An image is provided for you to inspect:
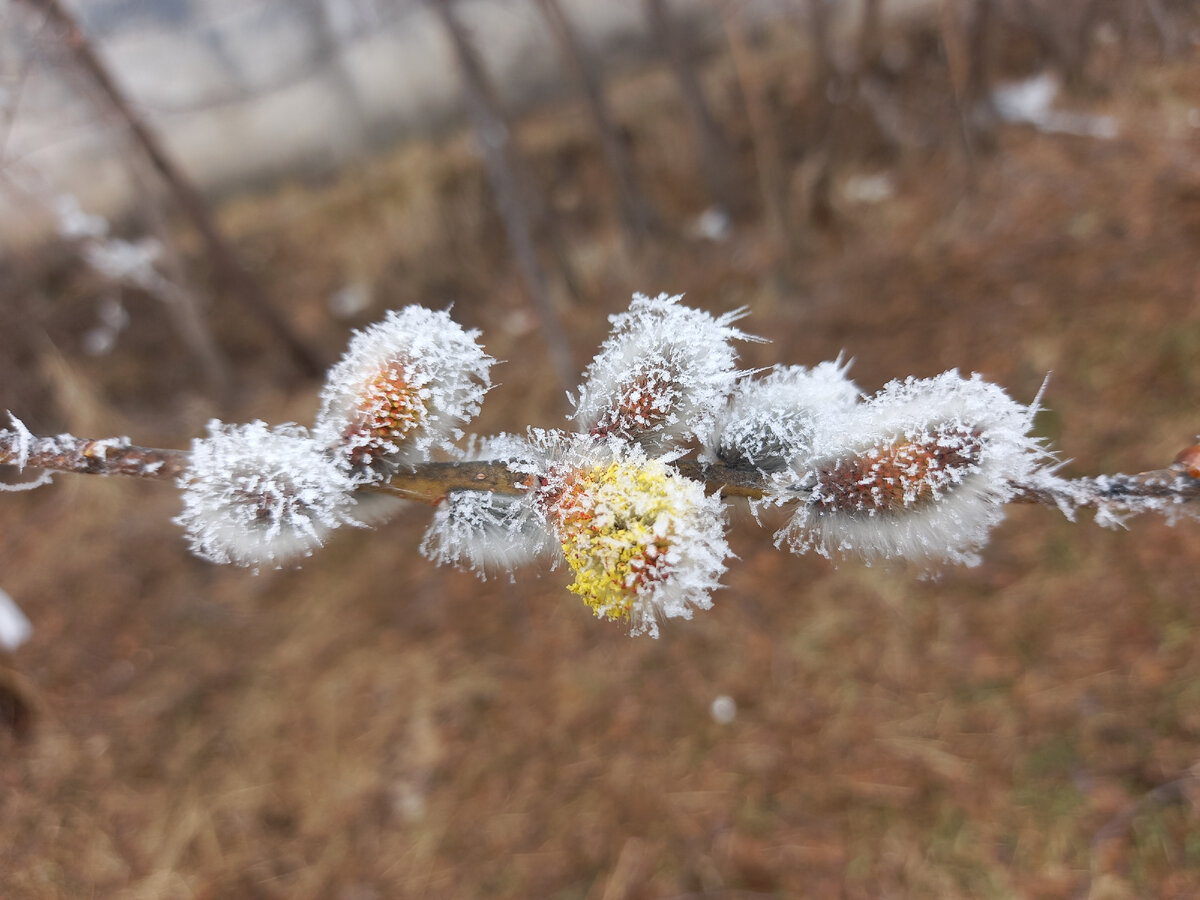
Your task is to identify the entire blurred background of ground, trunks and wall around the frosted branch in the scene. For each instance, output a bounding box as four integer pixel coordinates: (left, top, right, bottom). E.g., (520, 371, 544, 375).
(0, 0, 1200, 900)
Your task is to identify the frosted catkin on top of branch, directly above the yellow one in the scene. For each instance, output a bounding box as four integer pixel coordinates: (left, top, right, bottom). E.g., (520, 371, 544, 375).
(572, 294, 755, 451)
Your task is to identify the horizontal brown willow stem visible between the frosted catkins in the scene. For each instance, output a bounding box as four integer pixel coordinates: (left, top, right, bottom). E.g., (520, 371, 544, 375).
(0, 421, 1200, 509)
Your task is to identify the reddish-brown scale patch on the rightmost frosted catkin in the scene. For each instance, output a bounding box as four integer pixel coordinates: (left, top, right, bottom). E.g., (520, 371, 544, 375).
(818, 427, 983, 512)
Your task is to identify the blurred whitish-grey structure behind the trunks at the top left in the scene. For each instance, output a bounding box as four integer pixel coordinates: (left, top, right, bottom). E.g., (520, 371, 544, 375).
(0, 0, 931, 240)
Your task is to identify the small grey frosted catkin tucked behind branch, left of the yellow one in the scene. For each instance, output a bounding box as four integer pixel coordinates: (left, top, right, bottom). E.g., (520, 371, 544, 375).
(421, 434, 556, 578)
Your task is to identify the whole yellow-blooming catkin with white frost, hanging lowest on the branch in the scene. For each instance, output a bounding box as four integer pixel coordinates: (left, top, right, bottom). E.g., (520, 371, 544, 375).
(540, 440, 730, 637)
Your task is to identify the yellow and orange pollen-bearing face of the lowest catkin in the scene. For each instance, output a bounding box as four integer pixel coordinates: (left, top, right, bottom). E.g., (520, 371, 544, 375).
(553, 461, 686, 620)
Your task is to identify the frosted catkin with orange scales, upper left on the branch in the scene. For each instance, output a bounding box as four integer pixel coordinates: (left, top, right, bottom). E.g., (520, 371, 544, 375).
(314, 306, 496, 481)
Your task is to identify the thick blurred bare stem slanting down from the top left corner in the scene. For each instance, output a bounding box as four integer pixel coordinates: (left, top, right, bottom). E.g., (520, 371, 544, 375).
(24, 0, 325, 377)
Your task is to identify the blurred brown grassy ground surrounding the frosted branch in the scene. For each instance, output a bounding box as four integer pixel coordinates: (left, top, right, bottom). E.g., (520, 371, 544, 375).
(0, 12, 1200, 900)
